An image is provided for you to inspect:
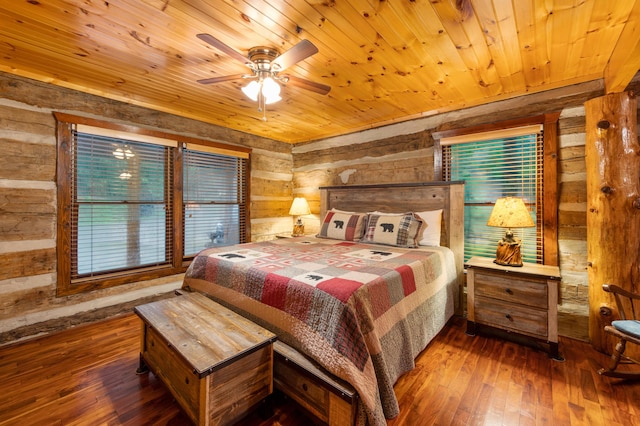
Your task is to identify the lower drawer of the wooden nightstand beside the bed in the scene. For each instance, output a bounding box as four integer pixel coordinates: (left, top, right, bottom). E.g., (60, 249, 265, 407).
(475, 296, 548, 338)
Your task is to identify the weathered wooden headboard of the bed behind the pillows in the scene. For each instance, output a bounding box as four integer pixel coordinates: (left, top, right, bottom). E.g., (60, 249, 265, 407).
(320, 182, 464, 314)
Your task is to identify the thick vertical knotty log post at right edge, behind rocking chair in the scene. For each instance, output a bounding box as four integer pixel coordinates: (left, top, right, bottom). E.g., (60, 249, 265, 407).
(585, 92, 640, 353)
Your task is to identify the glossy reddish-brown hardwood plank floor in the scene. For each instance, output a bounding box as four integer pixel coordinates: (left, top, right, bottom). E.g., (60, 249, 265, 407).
(0, 314, 640, 426)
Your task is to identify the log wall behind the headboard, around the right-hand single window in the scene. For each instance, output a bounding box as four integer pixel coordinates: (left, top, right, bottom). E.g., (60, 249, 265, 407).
(293, 78, 640, 340)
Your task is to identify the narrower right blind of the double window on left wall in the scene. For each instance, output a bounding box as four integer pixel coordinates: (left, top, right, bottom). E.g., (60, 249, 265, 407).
(183, 144, 247, 257)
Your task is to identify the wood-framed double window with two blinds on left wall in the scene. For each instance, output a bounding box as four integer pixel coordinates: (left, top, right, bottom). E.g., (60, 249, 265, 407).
(56, 114, 249, 295)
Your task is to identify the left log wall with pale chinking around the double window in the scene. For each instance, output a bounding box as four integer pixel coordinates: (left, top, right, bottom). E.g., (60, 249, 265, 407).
(0, 73, 293, 345)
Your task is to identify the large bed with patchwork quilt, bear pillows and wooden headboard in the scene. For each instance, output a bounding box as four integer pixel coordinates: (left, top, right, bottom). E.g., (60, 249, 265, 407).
(183, 182, 464, 425)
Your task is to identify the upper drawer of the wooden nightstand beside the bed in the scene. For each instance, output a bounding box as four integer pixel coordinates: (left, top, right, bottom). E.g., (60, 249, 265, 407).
(475, 270, 548, 309)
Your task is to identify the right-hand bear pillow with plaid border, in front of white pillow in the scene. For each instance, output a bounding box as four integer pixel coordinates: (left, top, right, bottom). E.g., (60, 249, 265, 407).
(360, 212, 424, 248)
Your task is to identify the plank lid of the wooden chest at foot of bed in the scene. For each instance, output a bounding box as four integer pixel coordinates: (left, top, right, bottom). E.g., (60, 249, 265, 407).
(134, 293, 276, 378)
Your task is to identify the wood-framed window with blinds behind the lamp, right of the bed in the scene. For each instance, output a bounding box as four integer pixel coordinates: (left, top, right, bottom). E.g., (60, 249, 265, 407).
(433, 114, 558, 265)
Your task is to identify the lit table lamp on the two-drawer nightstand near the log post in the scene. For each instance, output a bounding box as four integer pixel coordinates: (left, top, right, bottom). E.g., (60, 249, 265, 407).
(487, 197, 536, 266)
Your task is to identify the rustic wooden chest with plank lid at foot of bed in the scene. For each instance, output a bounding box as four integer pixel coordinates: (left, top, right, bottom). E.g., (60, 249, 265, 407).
(135, 293, 276, 425)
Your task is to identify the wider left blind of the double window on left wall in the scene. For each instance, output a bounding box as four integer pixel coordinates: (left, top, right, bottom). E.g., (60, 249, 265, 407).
(71, 131, 173, 279)
